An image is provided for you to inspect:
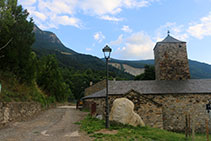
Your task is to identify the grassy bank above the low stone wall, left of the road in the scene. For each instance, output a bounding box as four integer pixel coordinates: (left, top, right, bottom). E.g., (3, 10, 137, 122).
(0, 72, 55, 107)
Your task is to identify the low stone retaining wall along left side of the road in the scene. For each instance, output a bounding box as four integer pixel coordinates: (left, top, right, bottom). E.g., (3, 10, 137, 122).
(0, 102, 42, 127)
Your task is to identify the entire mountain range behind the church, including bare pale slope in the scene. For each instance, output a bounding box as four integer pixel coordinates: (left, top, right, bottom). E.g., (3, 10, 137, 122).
(32, 25, 211, 79)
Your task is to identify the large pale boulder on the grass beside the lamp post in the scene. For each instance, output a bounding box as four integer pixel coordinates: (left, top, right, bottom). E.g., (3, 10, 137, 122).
(109, 98, 145, 126)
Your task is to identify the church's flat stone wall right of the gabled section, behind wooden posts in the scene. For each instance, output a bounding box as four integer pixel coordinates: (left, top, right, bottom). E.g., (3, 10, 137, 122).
(159, 94, 211, 132)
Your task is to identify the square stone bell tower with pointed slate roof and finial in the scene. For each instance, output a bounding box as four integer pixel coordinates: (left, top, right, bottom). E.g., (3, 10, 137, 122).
(154, 31, 190, 80)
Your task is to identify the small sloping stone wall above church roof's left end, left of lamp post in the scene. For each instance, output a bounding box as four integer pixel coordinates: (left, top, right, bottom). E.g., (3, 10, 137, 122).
(84, 80, 106, 96)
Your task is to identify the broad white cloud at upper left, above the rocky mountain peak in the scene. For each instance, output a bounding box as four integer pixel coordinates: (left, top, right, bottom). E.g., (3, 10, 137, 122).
(20, 0, 79, 29)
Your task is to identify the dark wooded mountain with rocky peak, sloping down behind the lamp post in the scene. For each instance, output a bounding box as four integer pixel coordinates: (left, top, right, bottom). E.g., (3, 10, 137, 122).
(32, 25, 133, 79)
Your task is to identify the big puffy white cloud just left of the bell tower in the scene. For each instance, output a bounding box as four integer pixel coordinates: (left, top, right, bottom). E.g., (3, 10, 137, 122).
(116, 32, 155, 59)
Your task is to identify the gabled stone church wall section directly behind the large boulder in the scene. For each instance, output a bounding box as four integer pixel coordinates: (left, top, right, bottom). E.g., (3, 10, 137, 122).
(84, 91, 163, 128)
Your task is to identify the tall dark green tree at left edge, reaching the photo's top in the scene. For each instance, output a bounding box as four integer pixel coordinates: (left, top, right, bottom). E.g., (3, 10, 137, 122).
(0, 0, 35, 82)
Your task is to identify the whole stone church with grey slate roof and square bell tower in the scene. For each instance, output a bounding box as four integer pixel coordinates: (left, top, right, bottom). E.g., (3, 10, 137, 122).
(83, 34, 211, 132)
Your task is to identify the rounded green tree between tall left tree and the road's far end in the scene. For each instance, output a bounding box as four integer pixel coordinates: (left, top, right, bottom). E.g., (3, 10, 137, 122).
(37, 55, 72, 102)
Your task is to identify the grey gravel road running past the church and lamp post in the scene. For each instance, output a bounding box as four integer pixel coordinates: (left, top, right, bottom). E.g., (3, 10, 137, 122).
(0, 106, 91, 141)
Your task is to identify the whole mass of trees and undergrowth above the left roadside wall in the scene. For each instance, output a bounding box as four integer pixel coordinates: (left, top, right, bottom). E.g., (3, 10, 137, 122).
(0, 0, 72, 104)
